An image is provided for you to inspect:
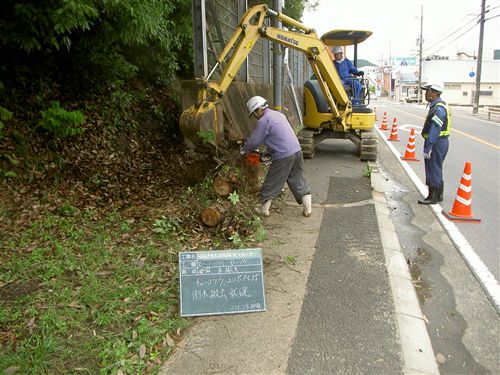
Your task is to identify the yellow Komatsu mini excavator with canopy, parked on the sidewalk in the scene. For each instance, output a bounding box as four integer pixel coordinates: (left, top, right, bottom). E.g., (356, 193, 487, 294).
(180, 4, 377, 160)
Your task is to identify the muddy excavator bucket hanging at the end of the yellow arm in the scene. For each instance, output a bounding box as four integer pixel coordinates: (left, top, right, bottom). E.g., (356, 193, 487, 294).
(179, 101, 224, 151)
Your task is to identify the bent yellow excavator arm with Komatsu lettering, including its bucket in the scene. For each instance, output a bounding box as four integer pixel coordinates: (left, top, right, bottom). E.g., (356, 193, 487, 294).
(180, 4, 352, 147)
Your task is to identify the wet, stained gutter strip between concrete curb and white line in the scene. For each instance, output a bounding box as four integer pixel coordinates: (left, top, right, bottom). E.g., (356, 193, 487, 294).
(377, 119, 500, 375)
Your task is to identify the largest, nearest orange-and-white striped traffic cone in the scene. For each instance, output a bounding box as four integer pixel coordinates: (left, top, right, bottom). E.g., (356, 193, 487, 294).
(443, 161, 481, 224)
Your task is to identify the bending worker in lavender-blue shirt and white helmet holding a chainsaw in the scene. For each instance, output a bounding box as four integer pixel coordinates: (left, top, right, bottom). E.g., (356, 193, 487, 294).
(240, 96, 312, 217)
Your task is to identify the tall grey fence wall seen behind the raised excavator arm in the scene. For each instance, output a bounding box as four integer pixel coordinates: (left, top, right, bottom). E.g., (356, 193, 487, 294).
(192, 0, 311, 85)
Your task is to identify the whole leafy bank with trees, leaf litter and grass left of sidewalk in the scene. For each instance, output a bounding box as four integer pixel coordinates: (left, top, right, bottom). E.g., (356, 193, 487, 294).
(0, 0, 314, 374)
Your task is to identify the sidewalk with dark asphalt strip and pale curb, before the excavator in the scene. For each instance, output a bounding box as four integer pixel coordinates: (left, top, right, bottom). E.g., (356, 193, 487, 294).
(160, 141, 438, 375)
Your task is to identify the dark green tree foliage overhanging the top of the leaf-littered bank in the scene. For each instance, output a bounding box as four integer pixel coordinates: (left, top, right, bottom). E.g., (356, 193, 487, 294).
(0, 0, 192, 93)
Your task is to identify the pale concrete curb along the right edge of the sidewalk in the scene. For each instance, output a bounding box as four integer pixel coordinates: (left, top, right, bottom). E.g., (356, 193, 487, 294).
(368, 162, 439, 375)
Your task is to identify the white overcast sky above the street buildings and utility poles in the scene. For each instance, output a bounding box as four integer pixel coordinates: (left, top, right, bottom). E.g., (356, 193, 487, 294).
(302, 0, 500, 65)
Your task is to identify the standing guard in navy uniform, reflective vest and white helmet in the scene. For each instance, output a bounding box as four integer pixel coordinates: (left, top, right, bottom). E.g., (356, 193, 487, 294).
(418, 83, 451, 204)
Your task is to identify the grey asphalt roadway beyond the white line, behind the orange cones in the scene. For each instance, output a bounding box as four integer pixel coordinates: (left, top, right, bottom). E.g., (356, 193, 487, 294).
(372, 98, 500, 280)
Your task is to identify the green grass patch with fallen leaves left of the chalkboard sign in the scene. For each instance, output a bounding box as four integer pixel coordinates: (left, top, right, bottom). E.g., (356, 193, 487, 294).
(0, 185, 267, 374)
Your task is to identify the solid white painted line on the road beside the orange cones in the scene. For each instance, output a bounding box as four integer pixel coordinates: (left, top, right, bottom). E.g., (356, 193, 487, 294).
(375, 127, 500, 314)
